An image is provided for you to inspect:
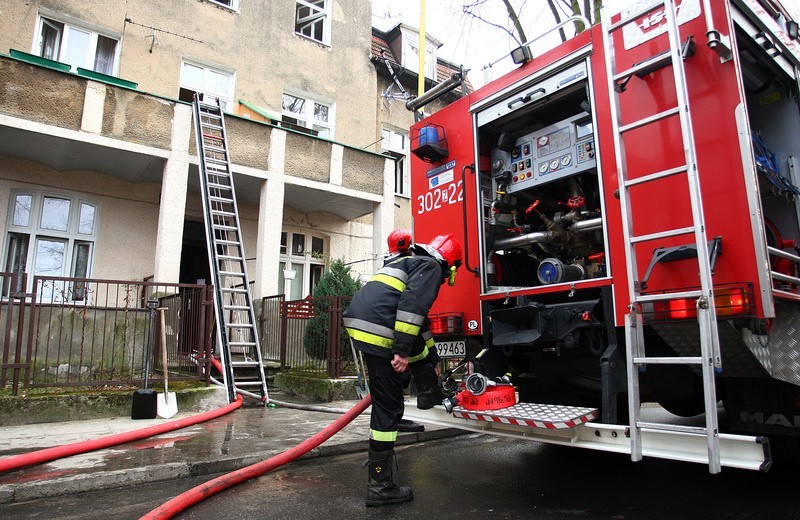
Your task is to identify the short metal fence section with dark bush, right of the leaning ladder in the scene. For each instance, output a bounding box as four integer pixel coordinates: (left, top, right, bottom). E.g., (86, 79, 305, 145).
(261, 295, 356, 379)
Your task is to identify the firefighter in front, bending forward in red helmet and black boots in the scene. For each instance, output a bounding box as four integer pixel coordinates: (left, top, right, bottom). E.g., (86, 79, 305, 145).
(344, 234, 462, 506)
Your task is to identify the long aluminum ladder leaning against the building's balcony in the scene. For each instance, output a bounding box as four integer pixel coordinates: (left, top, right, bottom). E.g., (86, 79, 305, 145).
(193, 96, 269, 404)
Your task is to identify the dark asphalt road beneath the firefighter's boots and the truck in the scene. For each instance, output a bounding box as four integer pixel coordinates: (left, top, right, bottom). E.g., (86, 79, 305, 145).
(0, 435, 800, 520)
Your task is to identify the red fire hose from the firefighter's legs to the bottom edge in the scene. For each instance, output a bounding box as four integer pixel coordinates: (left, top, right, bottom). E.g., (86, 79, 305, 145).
(140, 395, 372, 520)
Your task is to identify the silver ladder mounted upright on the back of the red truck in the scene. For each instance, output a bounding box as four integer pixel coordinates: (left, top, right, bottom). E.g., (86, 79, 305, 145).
(602, 0, 721, 473)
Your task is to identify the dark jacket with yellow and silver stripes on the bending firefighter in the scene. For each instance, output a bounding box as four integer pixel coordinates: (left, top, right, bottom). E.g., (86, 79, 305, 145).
(343, 255, 443, 357)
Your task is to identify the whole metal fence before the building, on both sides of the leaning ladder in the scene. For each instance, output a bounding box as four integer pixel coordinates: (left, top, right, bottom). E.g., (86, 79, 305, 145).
(0, 273, 356, 395)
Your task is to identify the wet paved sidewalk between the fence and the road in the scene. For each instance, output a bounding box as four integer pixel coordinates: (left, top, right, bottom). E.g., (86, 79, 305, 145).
(0, 392, 461, 503)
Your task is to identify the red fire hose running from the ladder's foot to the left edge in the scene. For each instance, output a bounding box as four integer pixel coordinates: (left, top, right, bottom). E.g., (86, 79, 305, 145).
(0, 395, 242, 472)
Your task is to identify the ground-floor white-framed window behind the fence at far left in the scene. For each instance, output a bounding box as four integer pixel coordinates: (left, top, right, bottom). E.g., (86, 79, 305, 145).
(3, 190, 98, 302)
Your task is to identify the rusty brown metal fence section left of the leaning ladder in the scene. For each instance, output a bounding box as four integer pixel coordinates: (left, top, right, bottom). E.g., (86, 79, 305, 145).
(0, 273, 213, 394)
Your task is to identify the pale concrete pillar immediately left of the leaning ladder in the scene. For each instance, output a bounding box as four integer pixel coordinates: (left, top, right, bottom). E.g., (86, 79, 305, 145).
(153, 104, 192, 283)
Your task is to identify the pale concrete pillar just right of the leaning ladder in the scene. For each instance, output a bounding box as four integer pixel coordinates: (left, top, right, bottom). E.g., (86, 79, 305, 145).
(252, 128, 286, 300)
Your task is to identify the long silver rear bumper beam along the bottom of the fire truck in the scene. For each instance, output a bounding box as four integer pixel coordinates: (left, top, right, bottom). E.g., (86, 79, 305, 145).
(403, 401, 772, 472)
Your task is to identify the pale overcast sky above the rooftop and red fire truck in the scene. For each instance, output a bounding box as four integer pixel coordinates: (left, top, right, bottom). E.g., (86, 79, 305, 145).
(372, 0, 800, 88)
